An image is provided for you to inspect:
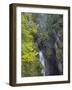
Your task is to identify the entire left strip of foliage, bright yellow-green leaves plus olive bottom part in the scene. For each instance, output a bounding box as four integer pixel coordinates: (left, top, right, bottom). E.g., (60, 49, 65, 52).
(21, 13, 41, 76)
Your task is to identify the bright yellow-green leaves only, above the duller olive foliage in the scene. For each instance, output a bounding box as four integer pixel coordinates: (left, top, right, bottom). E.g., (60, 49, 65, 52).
(22, 14, 37, 61)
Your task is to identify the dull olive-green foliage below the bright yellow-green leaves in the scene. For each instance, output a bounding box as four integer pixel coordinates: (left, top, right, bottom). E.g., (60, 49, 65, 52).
(22, 60, 42, 77)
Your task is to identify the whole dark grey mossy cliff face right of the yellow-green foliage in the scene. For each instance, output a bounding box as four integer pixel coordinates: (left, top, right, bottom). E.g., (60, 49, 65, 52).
(32, 14, 63, 75)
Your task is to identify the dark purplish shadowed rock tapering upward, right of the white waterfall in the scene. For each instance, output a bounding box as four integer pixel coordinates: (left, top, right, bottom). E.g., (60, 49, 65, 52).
(46, 49, 60, 75)
